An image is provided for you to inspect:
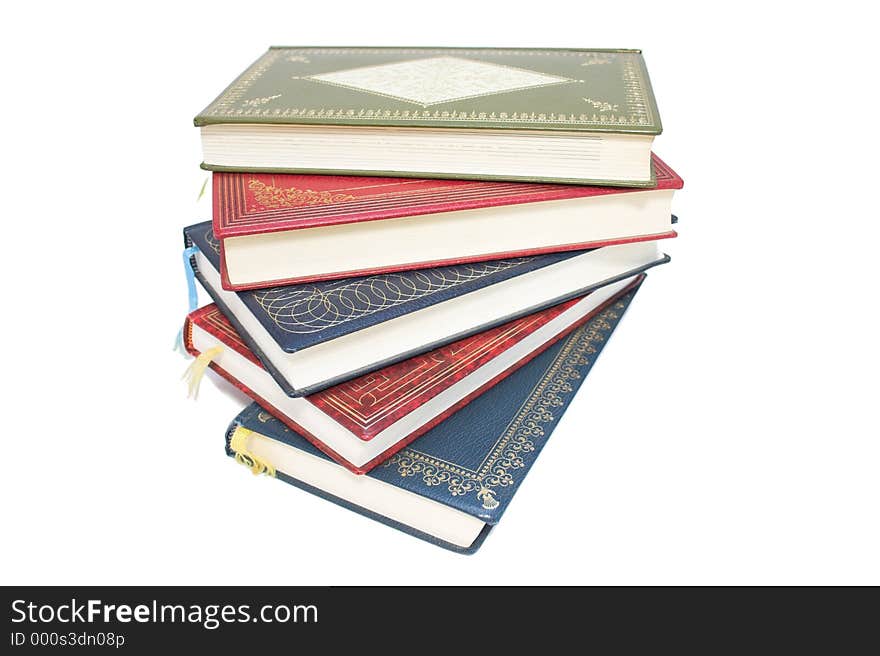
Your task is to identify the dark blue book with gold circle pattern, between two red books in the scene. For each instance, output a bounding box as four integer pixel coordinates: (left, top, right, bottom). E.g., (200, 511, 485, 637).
(184, 222, 669, 396)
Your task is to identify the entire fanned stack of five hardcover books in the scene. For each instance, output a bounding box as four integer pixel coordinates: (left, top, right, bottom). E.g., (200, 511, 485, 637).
(182, 47, 682, 553)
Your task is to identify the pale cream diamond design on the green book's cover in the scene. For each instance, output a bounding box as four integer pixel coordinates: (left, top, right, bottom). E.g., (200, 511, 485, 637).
(306, 57, 575, 107)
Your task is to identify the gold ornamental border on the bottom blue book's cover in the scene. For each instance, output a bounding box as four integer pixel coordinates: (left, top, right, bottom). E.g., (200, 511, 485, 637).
(383, 300, 626, 510)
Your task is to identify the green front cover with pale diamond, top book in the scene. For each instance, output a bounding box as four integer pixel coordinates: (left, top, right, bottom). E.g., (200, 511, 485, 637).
(194, 47, 662, 135)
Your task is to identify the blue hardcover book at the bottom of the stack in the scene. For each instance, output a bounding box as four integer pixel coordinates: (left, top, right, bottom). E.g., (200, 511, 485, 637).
(226, 287, 638, 553)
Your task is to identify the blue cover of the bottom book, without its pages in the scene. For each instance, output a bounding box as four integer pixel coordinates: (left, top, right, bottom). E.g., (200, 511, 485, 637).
(226, 280, 637, 553)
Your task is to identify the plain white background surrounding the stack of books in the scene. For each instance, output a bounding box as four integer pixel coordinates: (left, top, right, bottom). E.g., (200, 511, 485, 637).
(0, 0, 880, 584)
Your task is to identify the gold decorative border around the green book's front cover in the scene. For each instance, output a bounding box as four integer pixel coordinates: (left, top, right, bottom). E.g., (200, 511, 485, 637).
(198, 48, 657, 127)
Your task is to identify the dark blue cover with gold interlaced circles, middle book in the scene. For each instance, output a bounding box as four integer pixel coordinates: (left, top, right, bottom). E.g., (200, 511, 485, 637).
(184, 221, 584, 353)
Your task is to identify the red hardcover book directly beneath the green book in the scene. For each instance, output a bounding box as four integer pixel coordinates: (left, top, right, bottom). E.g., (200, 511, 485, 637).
(213, 156, 682, 290)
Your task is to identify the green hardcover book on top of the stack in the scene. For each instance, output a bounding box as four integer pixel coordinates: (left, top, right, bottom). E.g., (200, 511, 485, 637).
(195, 47, 661, 187)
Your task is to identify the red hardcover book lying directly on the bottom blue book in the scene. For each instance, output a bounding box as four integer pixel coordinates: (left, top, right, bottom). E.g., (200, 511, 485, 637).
(184, 275, 644, 474)
